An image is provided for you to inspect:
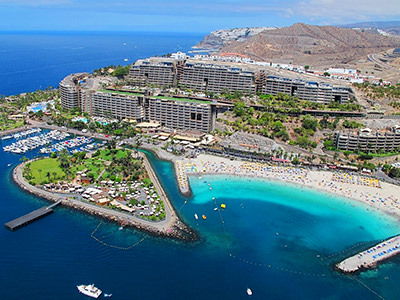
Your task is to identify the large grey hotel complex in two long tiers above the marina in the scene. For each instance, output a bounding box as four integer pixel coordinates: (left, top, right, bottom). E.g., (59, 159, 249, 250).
(60, 57, 352, 132)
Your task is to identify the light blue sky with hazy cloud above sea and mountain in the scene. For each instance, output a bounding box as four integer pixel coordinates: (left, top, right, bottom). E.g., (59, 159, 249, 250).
(0, 0, 400, 32)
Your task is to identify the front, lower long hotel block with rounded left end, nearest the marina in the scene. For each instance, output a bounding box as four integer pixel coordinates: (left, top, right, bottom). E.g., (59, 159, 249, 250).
(60, 75, 216, 132)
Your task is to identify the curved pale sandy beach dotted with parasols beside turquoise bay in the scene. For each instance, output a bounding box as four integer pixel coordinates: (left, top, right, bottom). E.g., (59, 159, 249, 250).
(175, 154, 400, 219)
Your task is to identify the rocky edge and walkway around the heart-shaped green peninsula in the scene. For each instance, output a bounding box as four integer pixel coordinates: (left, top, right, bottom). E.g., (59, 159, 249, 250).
(12, 161, 199, 242)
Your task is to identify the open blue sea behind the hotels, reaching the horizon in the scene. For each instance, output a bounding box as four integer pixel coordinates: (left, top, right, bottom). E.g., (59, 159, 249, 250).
(0, 32, 203, 96)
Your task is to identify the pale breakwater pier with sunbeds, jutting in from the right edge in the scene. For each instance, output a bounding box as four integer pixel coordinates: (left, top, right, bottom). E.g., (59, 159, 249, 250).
(336, 235, 400, 273)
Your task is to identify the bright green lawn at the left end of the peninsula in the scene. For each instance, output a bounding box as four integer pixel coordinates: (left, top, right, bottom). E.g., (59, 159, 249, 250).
(31, 158, 65, 184)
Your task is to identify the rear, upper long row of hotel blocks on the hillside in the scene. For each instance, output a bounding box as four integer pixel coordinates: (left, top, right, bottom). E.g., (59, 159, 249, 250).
(129, 58, 352, 104)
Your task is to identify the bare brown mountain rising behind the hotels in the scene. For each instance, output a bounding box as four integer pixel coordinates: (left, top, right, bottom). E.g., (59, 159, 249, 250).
(220, 23, 400, 67)
